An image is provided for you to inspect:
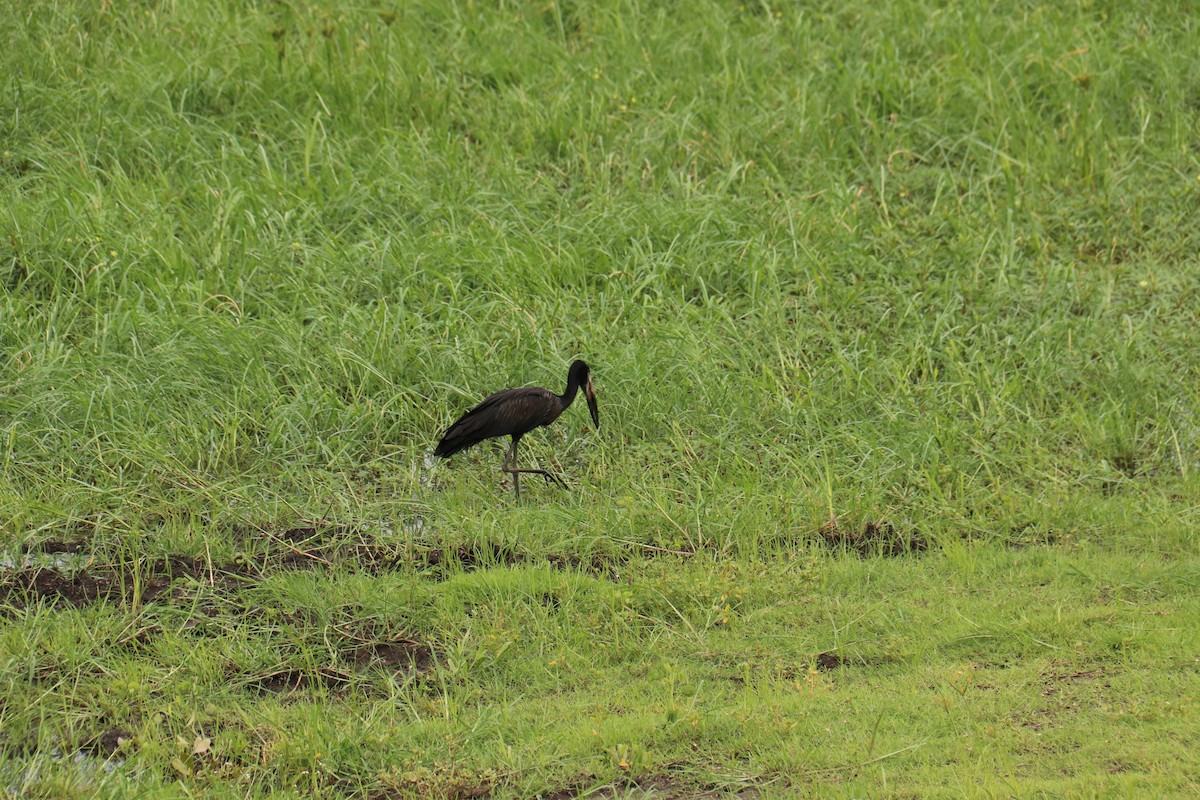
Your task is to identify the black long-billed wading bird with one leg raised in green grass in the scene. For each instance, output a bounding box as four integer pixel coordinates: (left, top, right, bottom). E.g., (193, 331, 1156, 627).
(433, 361, 600, 500)
